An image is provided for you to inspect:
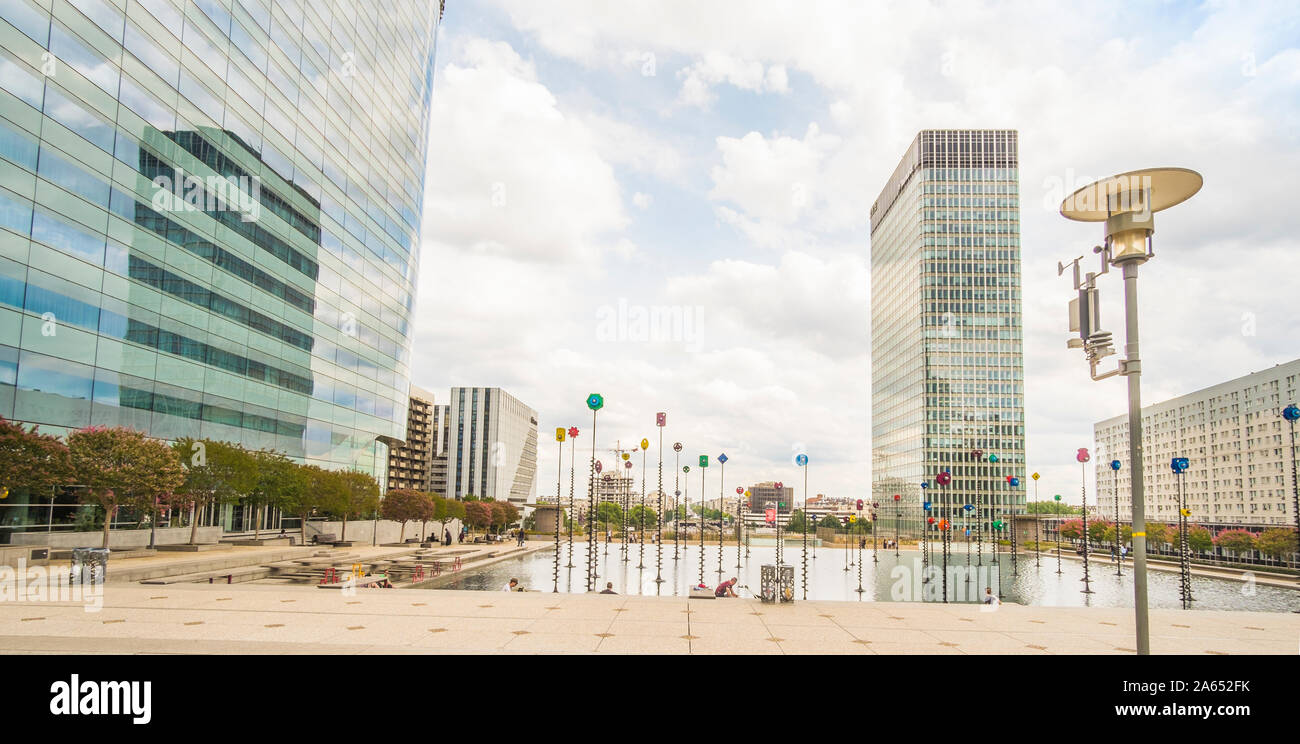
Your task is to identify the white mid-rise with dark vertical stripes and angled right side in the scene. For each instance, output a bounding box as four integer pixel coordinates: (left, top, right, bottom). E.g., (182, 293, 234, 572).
(445, 388, 537, 506)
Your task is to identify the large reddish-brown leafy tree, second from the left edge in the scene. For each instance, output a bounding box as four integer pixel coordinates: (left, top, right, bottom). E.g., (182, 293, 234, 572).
(68, 427, 185, 548)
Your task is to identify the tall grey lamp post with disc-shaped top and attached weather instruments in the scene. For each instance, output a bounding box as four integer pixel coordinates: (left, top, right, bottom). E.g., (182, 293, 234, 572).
(1057, 168, 1203, 654)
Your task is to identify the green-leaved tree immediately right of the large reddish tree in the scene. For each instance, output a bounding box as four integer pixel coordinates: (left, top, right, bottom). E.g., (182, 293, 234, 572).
(172, 437, 257, 545)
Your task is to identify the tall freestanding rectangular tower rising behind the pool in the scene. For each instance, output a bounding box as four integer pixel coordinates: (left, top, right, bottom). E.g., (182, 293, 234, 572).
(871, 130, 1027, 536)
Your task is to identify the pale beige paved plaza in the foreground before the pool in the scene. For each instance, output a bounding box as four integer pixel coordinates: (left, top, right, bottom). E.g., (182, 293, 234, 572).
(0, 584, 1300, 654)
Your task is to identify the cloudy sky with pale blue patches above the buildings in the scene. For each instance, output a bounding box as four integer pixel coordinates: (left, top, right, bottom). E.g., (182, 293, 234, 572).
(412, 0, 1300, 503)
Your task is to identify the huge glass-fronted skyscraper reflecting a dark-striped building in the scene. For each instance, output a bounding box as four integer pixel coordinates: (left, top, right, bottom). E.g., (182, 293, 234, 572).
(0, 0, 441, 496)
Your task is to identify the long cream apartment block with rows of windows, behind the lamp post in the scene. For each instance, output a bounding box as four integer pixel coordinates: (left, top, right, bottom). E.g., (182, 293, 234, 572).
(1095, 359, 1300, 528)
